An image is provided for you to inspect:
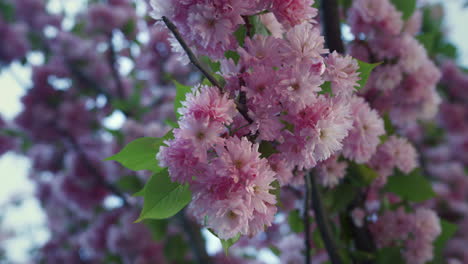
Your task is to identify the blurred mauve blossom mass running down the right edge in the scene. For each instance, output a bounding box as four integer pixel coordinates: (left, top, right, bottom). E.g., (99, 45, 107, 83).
(417, 61, 468, 263)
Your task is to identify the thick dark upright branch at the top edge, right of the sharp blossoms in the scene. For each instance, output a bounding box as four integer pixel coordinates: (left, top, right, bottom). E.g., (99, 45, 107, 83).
(320, 0, 345, 53)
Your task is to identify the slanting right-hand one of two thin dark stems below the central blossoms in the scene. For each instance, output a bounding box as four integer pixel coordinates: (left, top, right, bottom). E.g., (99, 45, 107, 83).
(306, 171, 343, 264)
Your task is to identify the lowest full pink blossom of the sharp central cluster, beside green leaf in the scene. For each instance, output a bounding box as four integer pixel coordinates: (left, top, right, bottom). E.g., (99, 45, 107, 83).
(186, 137, 276, 239)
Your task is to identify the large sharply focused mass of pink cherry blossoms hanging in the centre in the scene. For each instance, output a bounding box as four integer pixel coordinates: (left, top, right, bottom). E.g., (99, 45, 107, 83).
(153, 1, 392, 238)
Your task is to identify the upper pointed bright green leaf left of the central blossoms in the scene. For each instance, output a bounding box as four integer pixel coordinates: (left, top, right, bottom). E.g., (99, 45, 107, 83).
(105, 131, 173, 172)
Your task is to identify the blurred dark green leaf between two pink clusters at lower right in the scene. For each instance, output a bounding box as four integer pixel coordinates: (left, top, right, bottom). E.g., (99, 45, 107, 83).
(384, 169, 436, 202)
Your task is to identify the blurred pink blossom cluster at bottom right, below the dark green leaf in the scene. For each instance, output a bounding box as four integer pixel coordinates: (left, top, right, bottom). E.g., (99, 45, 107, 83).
(370, 208, 441, 264)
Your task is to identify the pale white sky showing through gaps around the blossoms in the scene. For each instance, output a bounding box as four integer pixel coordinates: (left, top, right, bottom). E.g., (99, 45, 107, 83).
(0, 0, 468, 263)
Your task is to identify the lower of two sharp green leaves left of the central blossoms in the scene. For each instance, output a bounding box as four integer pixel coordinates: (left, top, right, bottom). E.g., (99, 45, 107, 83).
(136, 169, 192, 222)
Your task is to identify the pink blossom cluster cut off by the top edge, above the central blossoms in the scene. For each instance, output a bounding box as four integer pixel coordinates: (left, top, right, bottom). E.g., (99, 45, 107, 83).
(151, 0, 317, 59)
